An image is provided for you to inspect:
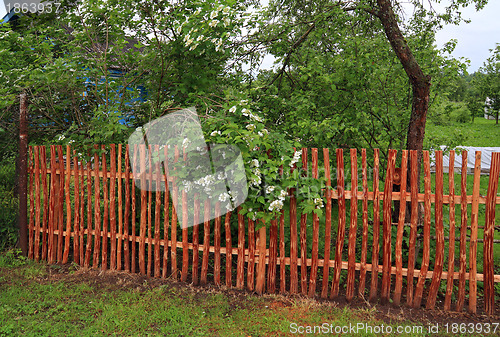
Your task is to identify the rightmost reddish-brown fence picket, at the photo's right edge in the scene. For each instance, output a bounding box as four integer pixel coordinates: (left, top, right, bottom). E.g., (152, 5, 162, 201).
(483, 152, 500, 315)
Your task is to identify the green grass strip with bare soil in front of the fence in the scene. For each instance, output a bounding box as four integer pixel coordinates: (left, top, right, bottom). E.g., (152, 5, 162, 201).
(0, 253, 498, 336)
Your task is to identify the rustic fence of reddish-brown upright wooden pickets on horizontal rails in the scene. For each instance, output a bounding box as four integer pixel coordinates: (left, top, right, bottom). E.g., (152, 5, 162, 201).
(29, 145, 500, 314)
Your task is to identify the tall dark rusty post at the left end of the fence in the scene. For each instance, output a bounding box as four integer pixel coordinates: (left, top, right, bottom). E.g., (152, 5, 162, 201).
(19, 92, 28, 256)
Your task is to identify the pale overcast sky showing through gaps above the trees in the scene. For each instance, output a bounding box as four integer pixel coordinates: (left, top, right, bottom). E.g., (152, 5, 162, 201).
(0, 0, 500, 73)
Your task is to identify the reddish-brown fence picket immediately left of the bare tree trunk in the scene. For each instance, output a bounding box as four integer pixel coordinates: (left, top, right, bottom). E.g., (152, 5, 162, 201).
(393, 150, 408, 305)
